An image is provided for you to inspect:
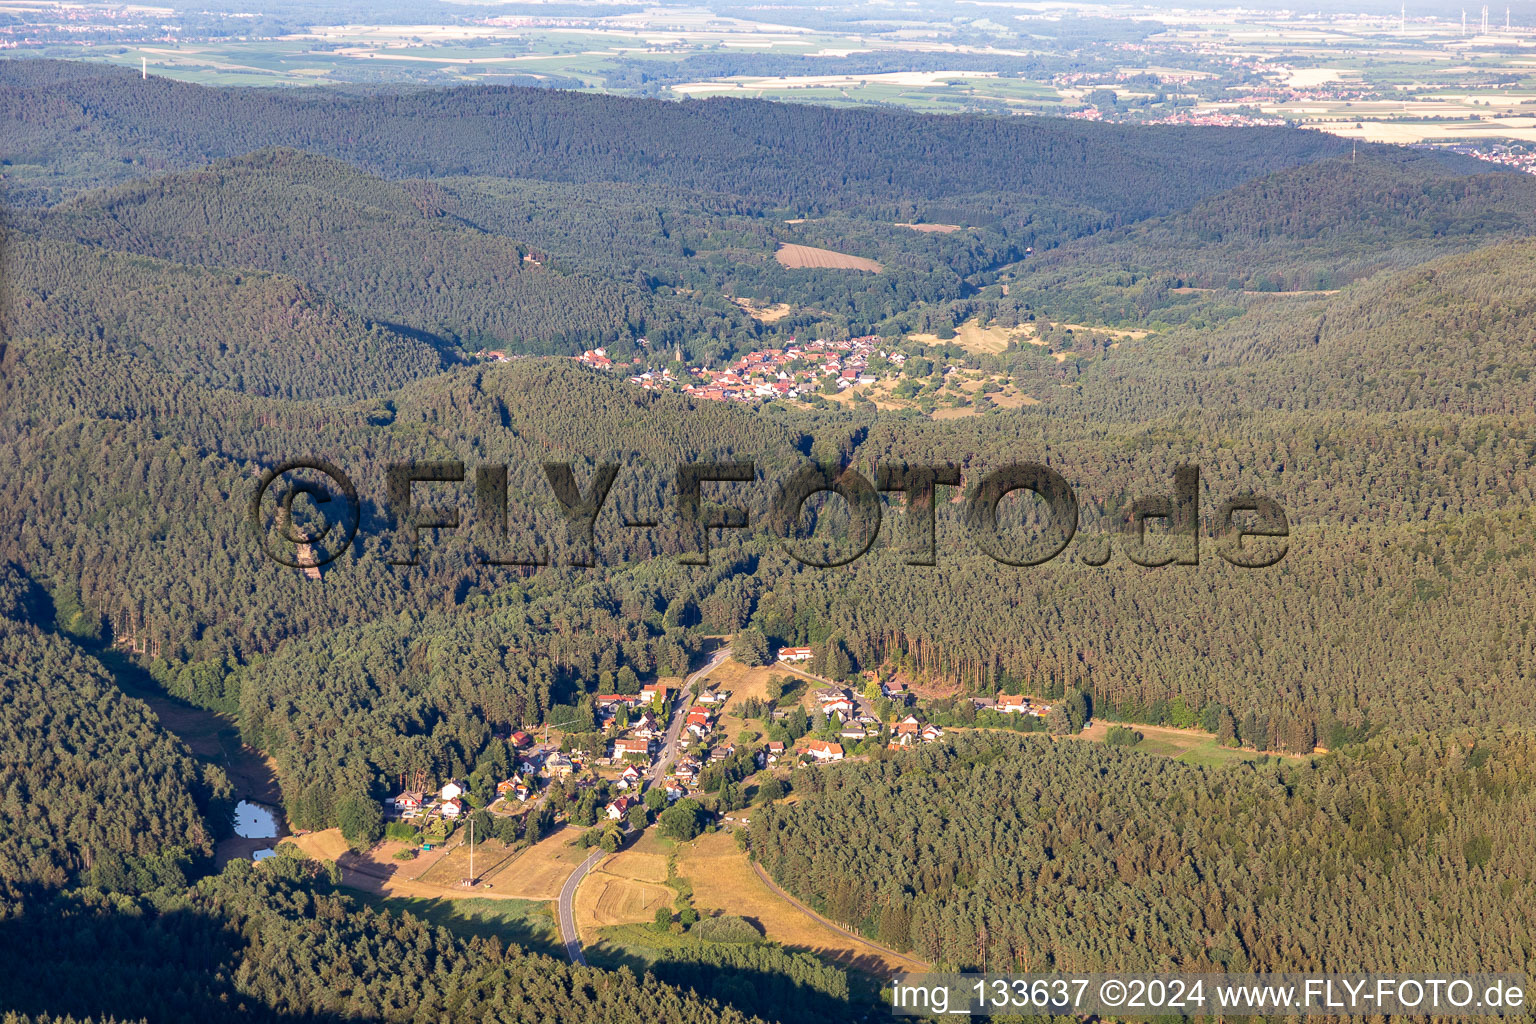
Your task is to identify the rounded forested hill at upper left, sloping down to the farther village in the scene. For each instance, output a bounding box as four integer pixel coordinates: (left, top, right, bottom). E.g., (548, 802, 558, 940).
(22, 149, 751, 353)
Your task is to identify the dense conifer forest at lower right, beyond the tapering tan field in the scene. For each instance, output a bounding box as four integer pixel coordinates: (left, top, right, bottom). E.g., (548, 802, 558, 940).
(751, 731, 1536, 973)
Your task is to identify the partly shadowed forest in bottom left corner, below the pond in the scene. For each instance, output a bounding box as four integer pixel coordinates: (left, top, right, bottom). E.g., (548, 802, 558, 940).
(0, 855, 754, 1024)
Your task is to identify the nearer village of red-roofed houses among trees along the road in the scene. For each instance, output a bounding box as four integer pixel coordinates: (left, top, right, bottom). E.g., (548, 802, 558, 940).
(371, 646, 1052, 865)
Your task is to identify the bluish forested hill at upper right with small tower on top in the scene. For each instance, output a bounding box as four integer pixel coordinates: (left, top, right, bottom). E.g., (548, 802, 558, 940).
(1003, 154, 1536, 314)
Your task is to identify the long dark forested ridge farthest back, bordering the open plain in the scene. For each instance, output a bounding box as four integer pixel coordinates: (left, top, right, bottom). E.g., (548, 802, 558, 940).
(0, 60, 1470, 220)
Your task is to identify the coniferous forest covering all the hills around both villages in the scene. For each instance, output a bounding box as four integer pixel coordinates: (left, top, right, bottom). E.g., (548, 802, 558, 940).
(0, 58, 1536, 1024)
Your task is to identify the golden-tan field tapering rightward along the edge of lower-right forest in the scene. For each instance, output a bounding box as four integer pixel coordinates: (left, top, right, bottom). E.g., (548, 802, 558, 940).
(677, 832, 914, 975)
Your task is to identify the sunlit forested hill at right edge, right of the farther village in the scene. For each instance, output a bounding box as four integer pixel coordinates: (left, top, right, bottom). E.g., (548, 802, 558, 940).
(1058, 239, 1536, 422)
